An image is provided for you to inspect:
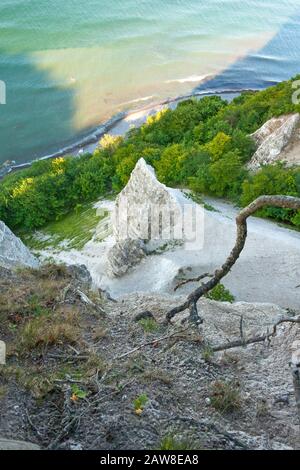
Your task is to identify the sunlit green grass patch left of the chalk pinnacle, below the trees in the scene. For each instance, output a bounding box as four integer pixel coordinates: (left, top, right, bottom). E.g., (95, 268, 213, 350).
(19, 204, 108, 250)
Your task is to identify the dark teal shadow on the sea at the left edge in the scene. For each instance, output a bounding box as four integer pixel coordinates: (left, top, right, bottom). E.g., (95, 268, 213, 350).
(0, 50, 75, 163)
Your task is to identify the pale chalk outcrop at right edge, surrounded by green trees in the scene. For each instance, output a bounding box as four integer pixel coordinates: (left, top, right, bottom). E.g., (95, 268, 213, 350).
(248, 113, 300, 171)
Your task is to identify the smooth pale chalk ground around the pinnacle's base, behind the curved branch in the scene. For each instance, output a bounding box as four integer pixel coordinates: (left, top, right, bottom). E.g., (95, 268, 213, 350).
(39, 194, 300, 308)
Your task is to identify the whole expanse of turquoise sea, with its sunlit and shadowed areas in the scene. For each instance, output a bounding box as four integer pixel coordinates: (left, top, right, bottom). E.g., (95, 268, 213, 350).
(0, 0, 300, 163)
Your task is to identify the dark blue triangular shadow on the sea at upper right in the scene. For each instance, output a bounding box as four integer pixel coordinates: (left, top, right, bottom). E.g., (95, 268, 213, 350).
(194, 11, 300, 92)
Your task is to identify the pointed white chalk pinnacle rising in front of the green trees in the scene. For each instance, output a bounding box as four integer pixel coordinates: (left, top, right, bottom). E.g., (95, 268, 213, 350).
(107, 158, 183, 276)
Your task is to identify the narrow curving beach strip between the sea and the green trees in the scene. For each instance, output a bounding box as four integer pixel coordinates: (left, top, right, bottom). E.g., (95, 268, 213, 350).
(0, 88, 258, 180)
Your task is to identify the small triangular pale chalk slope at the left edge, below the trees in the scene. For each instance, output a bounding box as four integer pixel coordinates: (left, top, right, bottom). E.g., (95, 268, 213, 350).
(0, 222, 39, 269)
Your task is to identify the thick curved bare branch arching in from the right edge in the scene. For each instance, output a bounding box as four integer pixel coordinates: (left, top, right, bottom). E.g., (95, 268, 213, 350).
(166, 196, 300, 323)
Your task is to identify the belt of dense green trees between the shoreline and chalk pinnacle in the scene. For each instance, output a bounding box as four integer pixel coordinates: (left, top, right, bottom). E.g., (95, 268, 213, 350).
(0, 77, 300, 230)
